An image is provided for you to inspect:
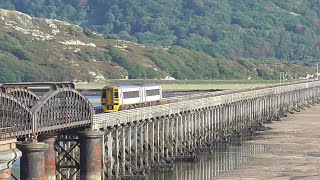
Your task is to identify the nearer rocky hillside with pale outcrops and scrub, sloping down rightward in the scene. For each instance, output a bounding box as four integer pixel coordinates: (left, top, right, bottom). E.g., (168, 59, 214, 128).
(0, 9, 315, 82)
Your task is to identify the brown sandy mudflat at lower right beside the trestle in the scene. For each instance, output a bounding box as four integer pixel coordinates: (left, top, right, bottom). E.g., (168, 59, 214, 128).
(217, 105, 320, 180)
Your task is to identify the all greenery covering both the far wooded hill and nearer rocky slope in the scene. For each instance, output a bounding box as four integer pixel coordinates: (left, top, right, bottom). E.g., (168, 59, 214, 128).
(0, 0, 320, 83)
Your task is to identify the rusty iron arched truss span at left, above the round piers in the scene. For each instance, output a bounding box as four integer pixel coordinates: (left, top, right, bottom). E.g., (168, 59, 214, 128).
(0, 83, 93, 140)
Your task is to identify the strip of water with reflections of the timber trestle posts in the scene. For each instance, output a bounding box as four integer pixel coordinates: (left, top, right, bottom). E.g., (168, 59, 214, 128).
(148, 144, 270, 180)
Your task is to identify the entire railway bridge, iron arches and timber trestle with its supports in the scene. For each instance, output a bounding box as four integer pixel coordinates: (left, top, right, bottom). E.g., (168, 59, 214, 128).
(0, 81, 320, 180)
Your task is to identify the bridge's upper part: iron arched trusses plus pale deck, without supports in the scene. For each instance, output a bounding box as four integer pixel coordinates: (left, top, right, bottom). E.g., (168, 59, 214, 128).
(0, 81, 320, 137)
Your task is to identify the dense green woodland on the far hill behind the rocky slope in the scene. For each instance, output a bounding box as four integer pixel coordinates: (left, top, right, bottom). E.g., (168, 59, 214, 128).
(0, 0, 320, 63)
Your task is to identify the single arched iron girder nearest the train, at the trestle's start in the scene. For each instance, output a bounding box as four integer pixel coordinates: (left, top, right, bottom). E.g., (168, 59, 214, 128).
(31, 88, 93, 133)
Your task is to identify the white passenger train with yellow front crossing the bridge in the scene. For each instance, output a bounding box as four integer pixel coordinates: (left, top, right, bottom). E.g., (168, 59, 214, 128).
(101, 84, 162, 112)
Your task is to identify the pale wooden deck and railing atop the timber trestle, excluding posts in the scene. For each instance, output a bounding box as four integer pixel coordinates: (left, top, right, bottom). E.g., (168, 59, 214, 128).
(92, 81, 320, 129)
